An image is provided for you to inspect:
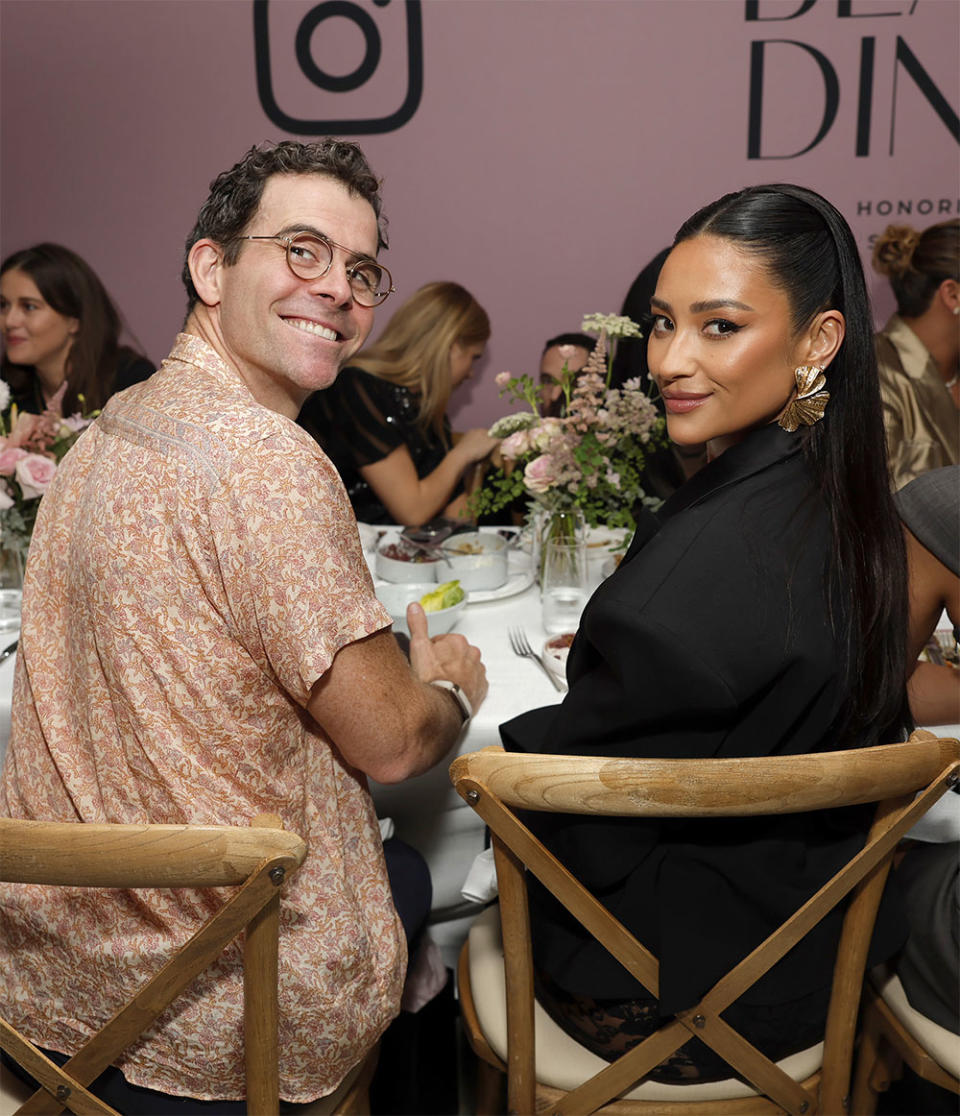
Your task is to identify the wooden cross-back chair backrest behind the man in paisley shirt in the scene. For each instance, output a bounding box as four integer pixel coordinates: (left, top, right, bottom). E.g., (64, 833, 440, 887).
(0, 815, 307, 1116)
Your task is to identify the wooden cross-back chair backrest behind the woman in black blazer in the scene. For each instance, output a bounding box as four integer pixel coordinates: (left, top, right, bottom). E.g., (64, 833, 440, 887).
(450, 730, 960, 1113)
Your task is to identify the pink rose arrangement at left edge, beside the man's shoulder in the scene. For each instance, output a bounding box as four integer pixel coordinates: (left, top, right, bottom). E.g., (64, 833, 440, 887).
(0, 379, 96, 558)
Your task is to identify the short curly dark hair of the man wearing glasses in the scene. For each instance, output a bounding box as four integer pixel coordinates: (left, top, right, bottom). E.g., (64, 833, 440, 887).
(181, 137, 387, 314)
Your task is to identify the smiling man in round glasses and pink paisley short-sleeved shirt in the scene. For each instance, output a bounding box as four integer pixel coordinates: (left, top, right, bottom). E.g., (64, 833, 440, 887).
(0, 140, 487, 1113)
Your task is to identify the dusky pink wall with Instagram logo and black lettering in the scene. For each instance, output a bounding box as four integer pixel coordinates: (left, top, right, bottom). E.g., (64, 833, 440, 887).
(0, 0, 960, 426)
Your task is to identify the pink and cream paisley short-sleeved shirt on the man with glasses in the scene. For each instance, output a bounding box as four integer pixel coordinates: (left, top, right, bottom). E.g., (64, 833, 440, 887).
(0, 335, 405, 1101)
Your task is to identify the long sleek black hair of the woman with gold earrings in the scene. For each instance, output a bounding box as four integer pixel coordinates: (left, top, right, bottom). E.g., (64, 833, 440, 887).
(675, 185, 908, 732)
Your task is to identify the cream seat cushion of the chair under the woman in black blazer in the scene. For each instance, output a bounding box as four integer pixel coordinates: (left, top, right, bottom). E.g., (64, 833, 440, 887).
(469, 906, 823, 1101)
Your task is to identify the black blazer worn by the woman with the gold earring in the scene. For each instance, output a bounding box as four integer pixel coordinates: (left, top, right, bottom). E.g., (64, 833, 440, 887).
(501, 425, 903, 1012)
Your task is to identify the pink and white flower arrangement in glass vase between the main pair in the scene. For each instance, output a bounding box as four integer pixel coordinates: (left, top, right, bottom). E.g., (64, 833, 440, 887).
(471, 314, 665, 530)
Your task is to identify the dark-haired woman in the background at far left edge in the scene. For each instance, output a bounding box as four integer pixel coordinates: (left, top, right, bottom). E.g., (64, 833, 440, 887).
(0, 244, 153, 415)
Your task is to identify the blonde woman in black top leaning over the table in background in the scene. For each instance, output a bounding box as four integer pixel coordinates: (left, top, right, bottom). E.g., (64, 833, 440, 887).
(299, 282, 497, 526)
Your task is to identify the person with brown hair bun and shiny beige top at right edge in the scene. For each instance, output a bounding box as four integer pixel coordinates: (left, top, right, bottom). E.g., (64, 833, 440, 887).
(873, 220, 960, 489)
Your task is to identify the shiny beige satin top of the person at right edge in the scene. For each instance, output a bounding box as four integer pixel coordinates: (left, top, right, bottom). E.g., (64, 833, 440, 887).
(876, 314, 960, 490)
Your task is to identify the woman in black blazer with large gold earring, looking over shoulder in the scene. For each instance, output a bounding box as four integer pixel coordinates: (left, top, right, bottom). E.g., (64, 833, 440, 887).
(501, 185, 906, 1080)
